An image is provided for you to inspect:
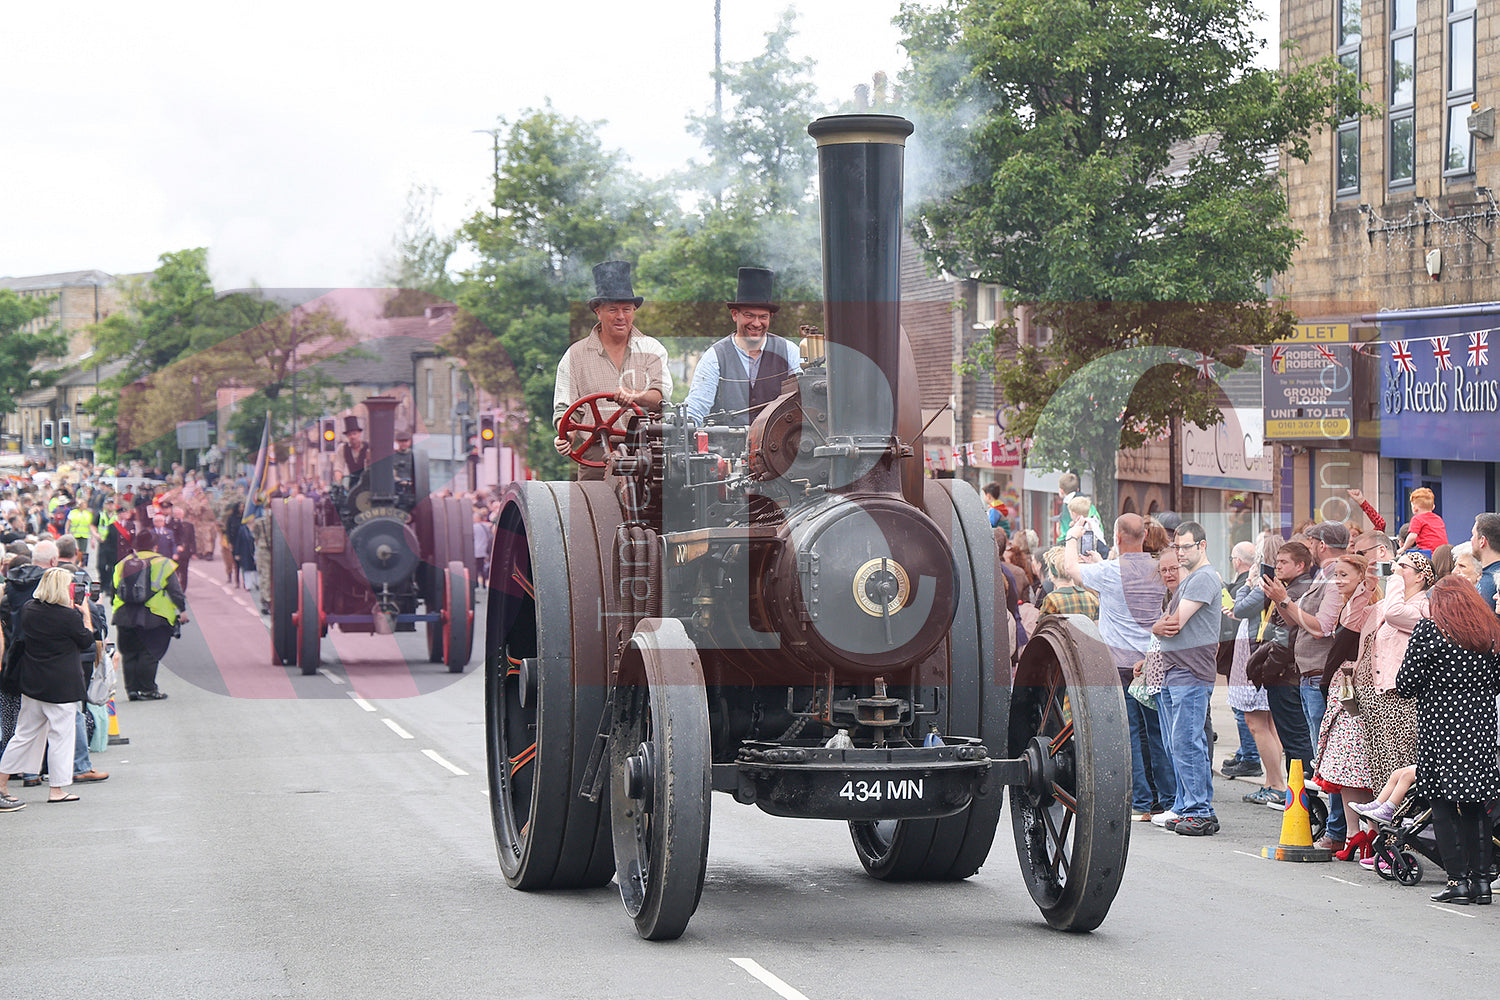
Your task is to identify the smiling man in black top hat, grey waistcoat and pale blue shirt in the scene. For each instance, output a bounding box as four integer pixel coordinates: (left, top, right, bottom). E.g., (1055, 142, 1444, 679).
(687, 267, 803, 427)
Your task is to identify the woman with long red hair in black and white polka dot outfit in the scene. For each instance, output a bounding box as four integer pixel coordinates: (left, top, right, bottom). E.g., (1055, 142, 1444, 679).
(1397, 576, 1500, 906)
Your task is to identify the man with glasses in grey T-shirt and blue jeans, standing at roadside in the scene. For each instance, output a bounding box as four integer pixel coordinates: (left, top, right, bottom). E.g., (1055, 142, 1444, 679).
(1152, 520, 1224, 837)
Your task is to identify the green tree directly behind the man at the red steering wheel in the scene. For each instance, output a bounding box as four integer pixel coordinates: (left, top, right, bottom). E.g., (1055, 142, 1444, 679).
(446, 105, 671, 478)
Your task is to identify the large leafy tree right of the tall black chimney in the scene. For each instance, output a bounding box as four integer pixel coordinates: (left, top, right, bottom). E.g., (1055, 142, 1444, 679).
(897, 0, 1371, 508)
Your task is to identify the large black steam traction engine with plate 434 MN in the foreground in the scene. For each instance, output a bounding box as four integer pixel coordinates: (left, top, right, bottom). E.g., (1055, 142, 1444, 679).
(485, 115, 1130, 939)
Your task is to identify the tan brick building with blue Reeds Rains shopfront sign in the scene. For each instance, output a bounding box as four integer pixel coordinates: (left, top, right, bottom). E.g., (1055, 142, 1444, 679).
(1268, 0, 1500, 541)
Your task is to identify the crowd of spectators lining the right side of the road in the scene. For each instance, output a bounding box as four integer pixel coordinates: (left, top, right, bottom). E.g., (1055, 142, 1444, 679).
(992, 475, 1500, 904)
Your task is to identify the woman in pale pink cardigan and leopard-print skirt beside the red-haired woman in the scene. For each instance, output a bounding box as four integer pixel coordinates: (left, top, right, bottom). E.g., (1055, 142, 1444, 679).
(1355, 552, 1434, 789)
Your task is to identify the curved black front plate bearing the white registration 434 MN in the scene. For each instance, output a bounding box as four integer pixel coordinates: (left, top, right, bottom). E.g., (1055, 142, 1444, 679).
(734, 739, 990, 820)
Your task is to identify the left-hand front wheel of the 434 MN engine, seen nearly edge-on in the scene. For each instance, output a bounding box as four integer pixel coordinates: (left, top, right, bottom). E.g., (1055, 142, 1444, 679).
(609, 618, 713, 942)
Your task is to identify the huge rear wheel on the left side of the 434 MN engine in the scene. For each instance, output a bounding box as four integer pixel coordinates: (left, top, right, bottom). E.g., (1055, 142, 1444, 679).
(485, 481, 621, 889)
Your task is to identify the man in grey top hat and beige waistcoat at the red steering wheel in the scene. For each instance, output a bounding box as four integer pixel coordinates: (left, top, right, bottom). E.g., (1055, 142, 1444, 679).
(552, 261, 672, 480)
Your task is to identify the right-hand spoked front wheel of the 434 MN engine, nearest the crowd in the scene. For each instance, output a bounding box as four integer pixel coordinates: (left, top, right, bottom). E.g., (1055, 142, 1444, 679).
(1010, 616, 1131, 931)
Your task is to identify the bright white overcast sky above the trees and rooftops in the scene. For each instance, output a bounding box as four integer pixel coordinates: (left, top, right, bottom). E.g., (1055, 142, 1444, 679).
(0, 0, 1275, 288)
